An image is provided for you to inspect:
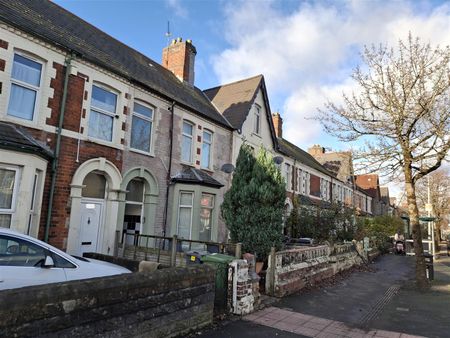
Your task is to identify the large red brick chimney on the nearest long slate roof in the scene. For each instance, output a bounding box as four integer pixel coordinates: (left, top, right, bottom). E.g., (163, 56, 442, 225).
(162, 38, 197, 85)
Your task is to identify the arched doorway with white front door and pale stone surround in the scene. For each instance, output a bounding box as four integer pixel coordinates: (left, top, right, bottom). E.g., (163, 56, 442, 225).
(67, 157, 122, 255)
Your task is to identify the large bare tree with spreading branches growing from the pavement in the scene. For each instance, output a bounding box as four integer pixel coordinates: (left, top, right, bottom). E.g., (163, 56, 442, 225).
(317, 34, 450, 288)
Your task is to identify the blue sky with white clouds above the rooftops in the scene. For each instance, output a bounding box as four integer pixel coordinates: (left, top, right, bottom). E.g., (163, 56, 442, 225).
(54, 0, 450, 194)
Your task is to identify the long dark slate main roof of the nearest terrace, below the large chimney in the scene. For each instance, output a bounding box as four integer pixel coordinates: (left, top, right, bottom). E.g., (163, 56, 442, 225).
(0, 0, 231, 129)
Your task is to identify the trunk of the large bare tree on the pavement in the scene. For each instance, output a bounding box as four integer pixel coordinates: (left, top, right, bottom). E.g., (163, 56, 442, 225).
(405, 172, 429, 290)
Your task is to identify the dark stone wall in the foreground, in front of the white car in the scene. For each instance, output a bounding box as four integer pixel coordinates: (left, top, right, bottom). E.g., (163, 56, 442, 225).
(0, 265, 214, 337)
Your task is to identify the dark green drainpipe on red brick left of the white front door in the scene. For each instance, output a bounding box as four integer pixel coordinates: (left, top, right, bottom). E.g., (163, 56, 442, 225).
(44, 54, 73, 242)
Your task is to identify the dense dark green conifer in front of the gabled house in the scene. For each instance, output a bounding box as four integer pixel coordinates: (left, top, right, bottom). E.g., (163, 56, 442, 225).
(221, 144, 285, 260)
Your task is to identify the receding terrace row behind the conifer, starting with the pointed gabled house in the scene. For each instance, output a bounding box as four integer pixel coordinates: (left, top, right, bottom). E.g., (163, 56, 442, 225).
(205, 75, 372, 226)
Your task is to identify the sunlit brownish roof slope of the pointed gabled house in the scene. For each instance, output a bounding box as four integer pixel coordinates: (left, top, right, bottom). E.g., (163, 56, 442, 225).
(203, 75, 263, 129)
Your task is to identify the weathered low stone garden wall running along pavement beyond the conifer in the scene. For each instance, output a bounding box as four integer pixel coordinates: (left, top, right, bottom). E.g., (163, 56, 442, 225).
(266, 244, 362, 297)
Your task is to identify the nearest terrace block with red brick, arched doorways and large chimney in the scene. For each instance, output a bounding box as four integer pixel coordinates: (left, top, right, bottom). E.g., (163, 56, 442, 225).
(0, 0, 233, 254)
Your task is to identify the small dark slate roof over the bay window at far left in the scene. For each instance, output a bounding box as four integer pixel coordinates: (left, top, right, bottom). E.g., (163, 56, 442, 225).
(0, 122, 53, 160)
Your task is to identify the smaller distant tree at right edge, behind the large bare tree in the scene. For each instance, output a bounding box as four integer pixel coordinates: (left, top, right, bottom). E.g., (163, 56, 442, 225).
(416, 168, 450, 240)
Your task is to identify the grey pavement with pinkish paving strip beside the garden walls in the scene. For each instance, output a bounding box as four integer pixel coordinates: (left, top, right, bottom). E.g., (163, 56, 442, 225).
(197, 248, 450, 338)
